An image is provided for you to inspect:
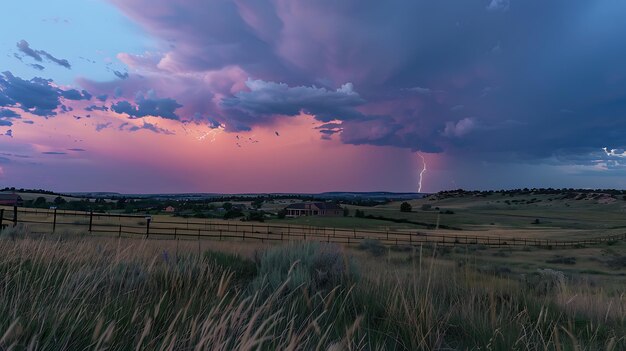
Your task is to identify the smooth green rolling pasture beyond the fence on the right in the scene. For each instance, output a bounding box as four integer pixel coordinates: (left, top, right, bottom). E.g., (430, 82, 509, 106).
(268, 194, 626, 239)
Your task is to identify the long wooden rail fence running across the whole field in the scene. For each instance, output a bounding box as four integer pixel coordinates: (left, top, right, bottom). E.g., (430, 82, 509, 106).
(0, 206, 626, 248)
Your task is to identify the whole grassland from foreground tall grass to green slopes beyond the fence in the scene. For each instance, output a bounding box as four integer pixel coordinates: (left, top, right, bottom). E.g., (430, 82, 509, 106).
(0, 194, 626, 350)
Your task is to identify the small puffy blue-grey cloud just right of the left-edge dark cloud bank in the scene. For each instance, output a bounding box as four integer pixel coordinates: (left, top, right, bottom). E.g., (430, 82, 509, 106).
(111, 91, 182, 120)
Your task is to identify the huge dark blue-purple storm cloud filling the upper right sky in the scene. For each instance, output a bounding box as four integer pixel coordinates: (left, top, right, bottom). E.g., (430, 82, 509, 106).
(90, 0, 626, 168)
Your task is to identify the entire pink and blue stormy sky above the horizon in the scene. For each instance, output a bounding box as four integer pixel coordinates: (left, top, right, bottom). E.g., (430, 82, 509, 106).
(0, 0, 626, 193)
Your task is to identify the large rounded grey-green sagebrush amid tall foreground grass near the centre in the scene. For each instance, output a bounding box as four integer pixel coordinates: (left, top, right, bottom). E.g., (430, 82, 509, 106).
(251, 242, 357, 296)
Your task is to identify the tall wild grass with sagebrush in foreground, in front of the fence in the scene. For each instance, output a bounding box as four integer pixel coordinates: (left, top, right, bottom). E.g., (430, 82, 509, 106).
(0, 230, 626, 350)
